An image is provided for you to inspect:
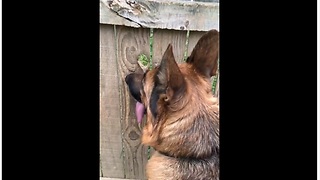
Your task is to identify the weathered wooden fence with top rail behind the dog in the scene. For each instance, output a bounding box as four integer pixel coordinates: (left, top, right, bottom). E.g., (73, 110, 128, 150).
(100, 0, 219, 179)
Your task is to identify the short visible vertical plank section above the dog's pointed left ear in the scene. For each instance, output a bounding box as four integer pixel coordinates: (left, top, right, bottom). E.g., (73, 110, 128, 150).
(152, 29, 187, 67)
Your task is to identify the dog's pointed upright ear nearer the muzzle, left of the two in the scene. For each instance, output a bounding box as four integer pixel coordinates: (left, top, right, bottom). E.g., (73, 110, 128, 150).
(156, 44, 185, 101)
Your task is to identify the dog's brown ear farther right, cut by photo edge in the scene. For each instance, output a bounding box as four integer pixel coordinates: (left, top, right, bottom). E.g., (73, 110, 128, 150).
(186, 30, 219, 78)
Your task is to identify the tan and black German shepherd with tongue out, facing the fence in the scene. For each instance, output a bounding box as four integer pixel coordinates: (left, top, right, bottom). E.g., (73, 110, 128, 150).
(125, 30, 219, 180)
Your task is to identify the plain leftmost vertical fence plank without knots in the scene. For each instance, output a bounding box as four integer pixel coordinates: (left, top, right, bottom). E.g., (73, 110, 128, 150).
(100, 25, 124, 178)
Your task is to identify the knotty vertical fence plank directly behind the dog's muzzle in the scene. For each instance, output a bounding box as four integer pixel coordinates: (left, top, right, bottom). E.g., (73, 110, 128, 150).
(116, 26, 150, 179)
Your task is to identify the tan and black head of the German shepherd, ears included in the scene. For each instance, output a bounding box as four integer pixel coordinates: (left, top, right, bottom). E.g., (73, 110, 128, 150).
(125, 30, 219, 155)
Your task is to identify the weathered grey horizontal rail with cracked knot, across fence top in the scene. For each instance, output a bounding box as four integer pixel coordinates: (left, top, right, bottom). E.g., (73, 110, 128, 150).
(100, 0, 219, 31)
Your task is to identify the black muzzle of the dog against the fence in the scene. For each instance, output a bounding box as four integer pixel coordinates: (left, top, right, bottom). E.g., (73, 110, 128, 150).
(125, 73, 143, 103)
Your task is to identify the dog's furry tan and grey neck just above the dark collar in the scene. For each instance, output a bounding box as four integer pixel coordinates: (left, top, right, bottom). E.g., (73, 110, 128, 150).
(151, 107, 219, 159)
